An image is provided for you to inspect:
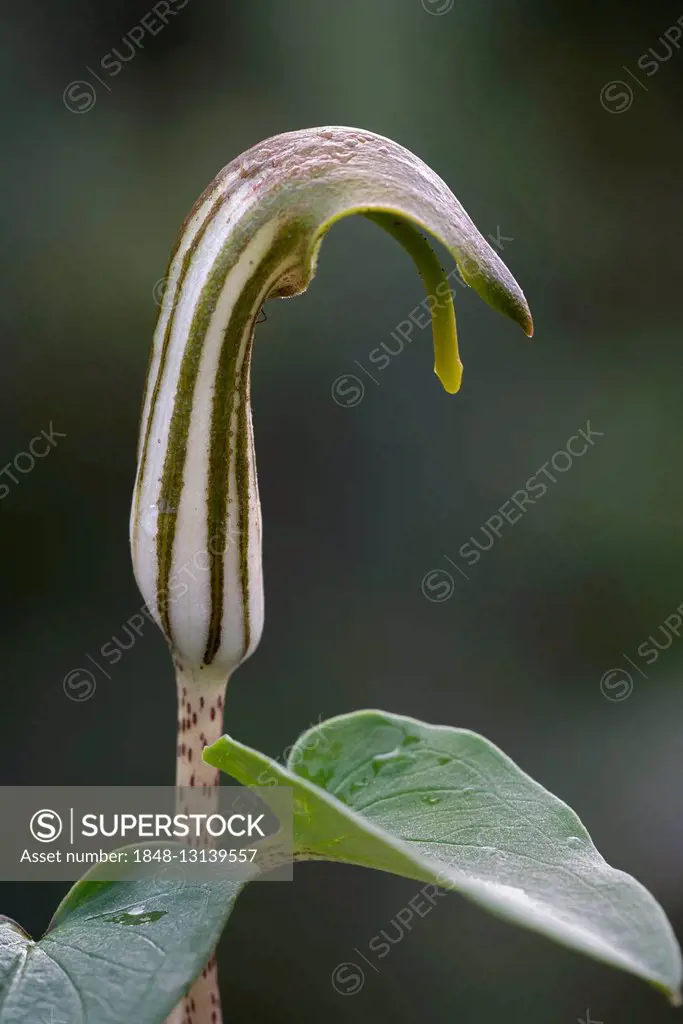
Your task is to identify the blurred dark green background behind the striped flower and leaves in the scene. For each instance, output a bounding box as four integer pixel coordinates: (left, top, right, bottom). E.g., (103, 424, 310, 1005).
(0, 0, 683, 1024)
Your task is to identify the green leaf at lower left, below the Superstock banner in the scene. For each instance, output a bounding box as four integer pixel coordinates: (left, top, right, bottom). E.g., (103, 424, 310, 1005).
(0, 868, 243, 1024)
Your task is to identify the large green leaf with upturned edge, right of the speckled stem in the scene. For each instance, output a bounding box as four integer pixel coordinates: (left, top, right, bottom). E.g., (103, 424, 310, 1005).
(204, 711, 681, 1004)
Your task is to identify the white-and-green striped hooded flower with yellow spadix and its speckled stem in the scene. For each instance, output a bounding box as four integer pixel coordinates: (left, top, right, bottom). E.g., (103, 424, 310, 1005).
(131, 128, 532, 1024)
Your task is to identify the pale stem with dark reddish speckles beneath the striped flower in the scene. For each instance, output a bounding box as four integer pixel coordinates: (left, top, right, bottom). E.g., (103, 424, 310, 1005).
(166, 666, 227, 1024)
